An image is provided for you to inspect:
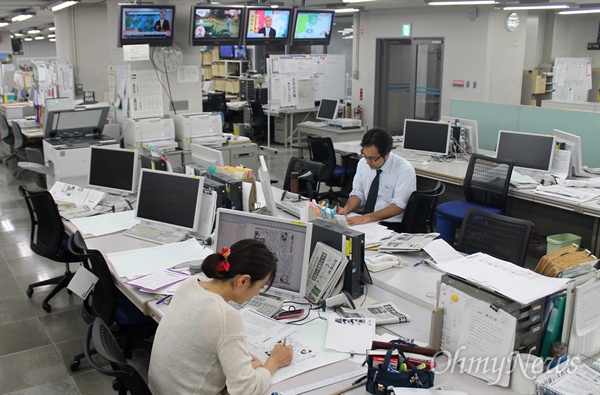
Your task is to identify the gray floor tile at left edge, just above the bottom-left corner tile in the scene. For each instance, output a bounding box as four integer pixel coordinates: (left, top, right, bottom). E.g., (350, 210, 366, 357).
(0, 318, 51, 355)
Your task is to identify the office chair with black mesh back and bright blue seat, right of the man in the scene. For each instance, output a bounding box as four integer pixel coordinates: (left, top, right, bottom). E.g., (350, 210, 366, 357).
(436, 154, 513, 244)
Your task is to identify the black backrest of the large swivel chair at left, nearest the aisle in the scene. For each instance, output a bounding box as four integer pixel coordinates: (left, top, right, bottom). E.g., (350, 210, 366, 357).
(19, 185, 65, 260)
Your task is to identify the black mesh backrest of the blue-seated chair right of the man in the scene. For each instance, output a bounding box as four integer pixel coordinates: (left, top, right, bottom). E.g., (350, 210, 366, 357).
(464, 154, 513, 212)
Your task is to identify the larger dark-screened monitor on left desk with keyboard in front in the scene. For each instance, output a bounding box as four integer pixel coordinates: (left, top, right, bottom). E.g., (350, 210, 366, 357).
(135, 169, 204, 231)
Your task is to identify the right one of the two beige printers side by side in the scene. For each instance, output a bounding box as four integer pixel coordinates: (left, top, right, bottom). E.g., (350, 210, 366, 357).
(174, 112, 226, 150)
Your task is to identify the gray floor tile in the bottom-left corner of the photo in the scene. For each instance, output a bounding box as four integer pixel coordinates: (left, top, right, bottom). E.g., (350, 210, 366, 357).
(0, 345, 70, 394)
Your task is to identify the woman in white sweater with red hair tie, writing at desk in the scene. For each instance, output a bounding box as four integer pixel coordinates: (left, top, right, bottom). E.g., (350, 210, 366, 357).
(148, 239, 292, 395)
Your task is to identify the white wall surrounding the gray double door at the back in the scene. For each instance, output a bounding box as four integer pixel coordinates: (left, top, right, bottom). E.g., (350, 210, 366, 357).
(352, 7, 526, 125)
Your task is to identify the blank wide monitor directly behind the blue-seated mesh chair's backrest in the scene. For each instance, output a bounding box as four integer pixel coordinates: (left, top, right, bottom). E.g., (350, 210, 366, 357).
(496, 130, 555, 171)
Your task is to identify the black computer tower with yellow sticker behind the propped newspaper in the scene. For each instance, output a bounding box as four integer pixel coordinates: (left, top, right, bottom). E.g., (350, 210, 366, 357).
(310, 219, 371, 299)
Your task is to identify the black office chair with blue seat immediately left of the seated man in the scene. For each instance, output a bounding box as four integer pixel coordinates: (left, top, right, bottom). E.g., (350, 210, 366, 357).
(307, 136, 356, 204)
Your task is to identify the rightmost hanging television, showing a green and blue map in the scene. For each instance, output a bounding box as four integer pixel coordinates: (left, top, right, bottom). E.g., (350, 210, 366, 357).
(292, 9, 335, 45)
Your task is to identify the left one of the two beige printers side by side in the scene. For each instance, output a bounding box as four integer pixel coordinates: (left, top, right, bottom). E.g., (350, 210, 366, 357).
(121, 118, 177, 152)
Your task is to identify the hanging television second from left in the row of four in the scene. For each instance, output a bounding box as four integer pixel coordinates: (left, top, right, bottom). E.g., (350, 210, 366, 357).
(190, 4, 244, 45)
